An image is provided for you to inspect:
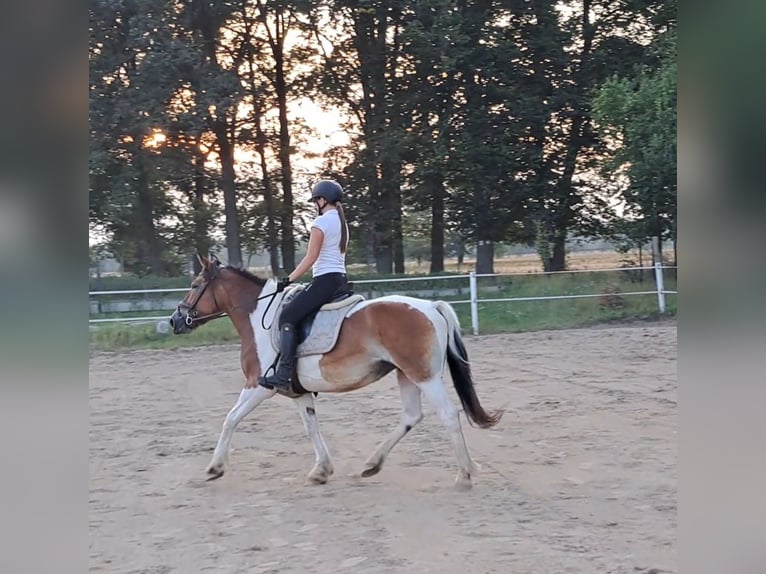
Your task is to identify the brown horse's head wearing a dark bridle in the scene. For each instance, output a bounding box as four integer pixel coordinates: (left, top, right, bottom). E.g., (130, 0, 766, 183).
(170, 254, 226, 335)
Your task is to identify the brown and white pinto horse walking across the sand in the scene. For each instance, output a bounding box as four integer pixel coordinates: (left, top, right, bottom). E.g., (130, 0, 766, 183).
(170, 257, 502, 488)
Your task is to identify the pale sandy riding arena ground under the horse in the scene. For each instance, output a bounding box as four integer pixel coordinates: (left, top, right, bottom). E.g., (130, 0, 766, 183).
(90, 323, 677, 574)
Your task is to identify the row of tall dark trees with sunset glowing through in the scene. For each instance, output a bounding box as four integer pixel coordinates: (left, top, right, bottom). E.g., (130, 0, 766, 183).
(90, 0, 676, 275)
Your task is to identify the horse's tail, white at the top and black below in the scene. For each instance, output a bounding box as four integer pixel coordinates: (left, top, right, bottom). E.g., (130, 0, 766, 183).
(434, 301, 503, 428)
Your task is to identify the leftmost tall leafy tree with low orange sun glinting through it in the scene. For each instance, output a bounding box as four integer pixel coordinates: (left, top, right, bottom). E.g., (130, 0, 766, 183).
(89, 0, 186, 275)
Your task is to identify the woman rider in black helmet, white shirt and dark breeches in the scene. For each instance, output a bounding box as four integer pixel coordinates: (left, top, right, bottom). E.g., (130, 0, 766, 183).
(260, 179, 348, 396)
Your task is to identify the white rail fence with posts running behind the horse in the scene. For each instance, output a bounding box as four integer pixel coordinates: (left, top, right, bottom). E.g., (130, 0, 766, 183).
(88, 263, 678, 335)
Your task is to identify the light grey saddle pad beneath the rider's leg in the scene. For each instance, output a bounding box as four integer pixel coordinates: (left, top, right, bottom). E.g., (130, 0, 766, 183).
(271, 283, 365, 359)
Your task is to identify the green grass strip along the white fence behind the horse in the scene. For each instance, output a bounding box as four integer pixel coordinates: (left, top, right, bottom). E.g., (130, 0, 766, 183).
(90, 271, 677, 351)
